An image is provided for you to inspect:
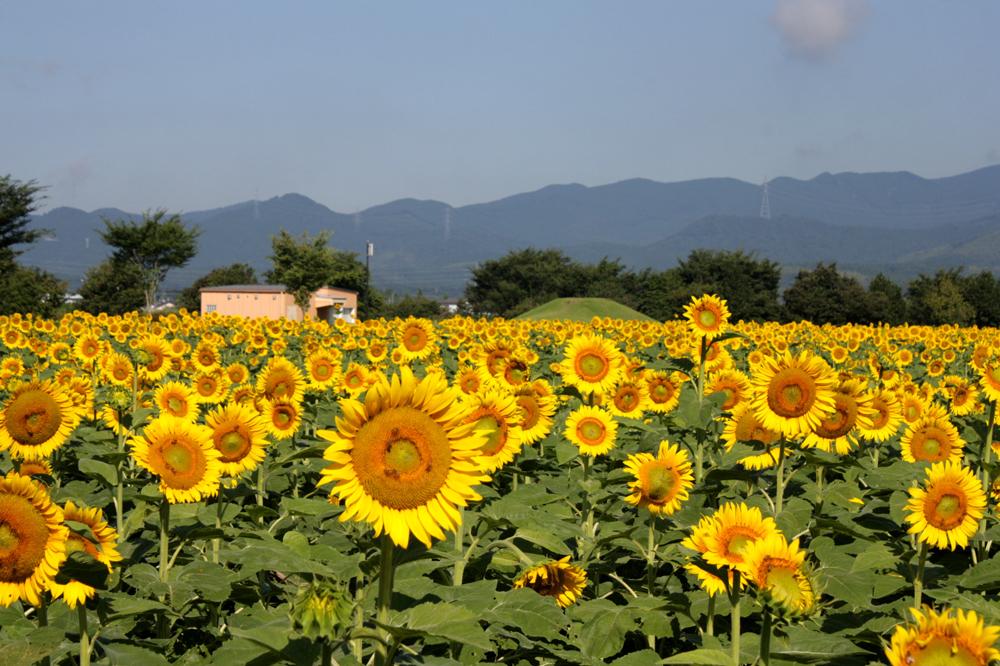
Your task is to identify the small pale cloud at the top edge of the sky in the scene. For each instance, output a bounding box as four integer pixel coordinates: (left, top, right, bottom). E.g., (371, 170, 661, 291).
(771, 0, 868, 60)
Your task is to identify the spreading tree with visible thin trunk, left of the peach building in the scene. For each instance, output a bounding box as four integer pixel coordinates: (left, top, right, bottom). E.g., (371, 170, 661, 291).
(101, 210, 200, 311)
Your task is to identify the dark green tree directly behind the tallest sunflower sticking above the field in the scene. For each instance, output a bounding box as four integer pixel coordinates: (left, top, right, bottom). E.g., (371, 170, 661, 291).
(676, 250, 781, 321)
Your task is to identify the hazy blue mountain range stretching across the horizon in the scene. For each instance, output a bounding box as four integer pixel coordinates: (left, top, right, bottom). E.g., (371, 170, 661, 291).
(22, 165, 1000, 296)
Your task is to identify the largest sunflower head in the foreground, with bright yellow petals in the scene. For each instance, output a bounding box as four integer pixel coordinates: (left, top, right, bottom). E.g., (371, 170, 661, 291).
(318, 368, 489, 548)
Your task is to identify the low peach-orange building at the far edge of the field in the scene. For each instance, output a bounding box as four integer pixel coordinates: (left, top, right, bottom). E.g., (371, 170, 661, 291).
(201, 284, 358, 323)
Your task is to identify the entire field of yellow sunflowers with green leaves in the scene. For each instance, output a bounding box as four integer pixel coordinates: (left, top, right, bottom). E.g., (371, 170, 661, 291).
(0, 296, 1000, 666)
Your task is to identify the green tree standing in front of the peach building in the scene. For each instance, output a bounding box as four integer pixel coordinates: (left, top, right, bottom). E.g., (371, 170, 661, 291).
(264, 229, 383, 317)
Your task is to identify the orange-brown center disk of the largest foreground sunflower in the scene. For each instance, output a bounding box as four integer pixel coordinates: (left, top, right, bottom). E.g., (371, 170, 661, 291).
(351, 406, 452, 510)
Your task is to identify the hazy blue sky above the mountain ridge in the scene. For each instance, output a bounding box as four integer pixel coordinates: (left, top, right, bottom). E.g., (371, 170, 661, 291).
(0, 0, 1000, 212)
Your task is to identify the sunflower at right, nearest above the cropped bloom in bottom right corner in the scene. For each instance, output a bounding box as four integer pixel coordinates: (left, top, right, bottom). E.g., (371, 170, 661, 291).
(906, 461, 986, 550)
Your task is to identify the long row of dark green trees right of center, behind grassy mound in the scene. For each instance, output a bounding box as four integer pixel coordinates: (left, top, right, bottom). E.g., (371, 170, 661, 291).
(465, 248, 1000, 326)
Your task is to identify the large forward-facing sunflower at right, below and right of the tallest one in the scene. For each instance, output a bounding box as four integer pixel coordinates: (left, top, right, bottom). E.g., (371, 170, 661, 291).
(751, 351, 837, 437)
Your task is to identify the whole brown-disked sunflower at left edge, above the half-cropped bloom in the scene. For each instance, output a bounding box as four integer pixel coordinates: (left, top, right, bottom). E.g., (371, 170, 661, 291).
(0, 380, 80, 460)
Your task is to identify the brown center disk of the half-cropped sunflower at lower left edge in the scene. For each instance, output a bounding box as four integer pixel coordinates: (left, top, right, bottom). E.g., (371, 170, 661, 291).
(0, 495, 49, 583)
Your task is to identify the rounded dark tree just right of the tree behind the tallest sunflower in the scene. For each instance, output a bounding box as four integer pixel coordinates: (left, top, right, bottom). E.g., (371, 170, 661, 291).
(785, 263, 867, 324)
